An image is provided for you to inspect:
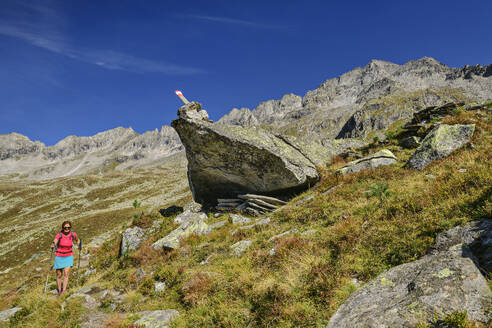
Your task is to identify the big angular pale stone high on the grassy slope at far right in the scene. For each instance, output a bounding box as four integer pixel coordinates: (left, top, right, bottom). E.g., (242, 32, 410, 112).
(407, 124, 475, 170)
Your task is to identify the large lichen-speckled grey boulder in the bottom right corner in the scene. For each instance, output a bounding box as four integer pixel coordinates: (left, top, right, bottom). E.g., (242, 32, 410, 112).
(328, 219, 492, 328)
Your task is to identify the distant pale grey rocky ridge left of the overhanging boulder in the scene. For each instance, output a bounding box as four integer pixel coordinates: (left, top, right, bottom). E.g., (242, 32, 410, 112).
(0, 126, 183, 180)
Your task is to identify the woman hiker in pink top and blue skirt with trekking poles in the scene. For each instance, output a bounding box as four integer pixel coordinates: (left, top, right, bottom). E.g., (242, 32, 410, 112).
(51, 221, 80, 295)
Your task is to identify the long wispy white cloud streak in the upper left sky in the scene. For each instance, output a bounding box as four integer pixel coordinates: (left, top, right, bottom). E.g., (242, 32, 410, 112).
(0, 2, 204, 75)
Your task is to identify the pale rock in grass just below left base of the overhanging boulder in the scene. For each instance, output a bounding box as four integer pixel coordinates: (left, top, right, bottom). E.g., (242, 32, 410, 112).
(152, 216, 212, 250)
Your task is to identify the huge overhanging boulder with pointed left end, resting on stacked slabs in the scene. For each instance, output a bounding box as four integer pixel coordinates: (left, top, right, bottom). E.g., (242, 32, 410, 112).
(172, 103, 330, 205)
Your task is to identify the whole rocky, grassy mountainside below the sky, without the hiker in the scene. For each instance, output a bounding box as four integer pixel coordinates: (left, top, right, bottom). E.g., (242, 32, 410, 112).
(0, 58, 492, 328)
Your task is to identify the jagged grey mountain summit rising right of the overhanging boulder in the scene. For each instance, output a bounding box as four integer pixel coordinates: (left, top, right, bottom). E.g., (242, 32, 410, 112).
(219, 57, 492, 140)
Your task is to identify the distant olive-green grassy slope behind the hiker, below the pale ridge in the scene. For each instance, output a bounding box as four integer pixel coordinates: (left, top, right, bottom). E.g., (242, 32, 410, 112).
(0, 151, 191, 289)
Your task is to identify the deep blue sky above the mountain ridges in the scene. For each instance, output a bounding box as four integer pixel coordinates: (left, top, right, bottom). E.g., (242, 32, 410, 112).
(0, 0, 492, 145)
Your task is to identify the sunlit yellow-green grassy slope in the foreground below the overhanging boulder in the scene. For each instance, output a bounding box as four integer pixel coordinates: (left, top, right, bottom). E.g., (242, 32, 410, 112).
(2, 107, 492, 327)
